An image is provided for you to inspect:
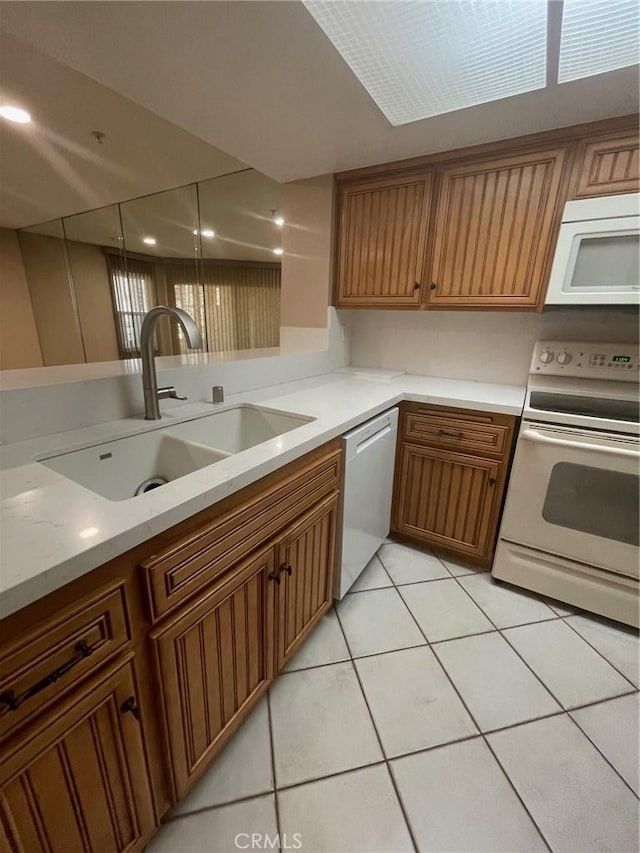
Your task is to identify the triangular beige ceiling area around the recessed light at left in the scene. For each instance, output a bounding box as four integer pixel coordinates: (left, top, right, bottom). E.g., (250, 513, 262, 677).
(0, 32, 243, 228)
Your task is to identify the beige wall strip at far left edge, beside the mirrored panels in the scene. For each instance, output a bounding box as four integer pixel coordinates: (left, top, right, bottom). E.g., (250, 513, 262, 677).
(0, 228, 42, 370)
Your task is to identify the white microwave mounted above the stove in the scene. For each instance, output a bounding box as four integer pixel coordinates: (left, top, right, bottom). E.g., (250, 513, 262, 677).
(545, 193, 640, 305)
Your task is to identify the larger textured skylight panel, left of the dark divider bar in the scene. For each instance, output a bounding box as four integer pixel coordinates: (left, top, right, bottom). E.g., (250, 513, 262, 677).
(303, 0, 547, 125)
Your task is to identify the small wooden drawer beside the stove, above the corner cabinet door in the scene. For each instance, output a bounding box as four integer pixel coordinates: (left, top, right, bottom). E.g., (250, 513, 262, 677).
(402, 403, 514, 457)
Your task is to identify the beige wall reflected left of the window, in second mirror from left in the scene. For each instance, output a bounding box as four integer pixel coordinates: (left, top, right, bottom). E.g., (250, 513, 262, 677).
(67, 240, 120, 361)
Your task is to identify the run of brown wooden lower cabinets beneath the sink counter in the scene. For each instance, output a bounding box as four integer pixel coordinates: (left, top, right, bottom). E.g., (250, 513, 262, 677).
(0, 440, 342, 853)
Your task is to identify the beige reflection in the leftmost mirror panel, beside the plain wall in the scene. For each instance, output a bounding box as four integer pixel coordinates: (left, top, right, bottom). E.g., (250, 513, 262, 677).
(18, 231, 85, 365)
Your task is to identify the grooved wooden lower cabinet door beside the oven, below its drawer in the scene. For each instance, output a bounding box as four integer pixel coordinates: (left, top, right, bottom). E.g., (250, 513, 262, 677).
(394, 444, 501, 557)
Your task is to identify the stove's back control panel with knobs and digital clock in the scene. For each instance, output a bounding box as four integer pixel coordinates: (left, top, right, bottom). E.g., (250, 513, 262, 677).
(531, 341, 639, 382)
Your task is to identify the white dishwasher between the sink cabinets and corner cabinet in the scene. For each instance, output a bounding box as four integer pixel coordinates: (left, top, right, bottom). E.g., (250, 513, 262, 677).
(334, 409, 398, 598)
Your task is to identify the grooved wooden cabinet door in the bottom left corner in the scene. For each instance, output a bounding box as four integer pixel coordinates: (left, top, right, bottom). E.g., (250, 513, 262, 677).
(0, 665, 154, 853)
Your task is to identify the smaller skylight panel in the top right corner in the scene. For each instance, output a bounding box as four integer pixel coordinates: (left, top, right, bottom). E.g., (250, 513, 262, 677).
(558, 0, 640, 83)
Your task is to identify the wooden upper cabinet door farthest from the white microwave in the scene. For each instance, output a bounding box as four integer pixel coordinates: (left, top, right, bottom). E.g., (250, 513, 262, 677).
(335, 170, 433, 308)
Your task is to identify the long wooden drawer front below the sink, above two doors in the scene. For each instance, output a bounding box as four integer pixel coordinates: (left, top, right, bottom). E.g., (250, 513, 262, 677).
(141, 450, 341, 620)
